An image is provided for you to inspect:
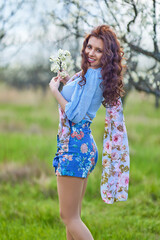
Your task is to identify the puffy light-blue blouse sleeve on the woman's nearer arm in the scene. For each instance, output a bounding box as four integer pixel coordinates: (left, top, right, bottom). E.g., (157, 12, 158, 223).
(65, 68, 101, 123)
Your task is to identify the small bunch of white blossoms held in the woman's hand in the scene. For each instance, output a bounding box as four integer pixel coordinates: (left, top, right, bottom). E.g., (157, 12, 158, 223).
(49, 49, 71, 91)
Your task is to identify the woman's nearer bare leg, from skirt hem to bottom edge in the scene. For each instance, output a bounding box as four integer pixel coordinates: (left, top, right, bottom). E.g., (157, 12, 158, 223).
(57, 176, 93, 240)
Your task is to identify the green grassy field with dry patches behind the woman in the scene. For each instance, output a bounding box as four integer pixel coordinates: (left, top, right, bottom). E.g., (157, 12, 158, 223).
(0, 85, 160, 240)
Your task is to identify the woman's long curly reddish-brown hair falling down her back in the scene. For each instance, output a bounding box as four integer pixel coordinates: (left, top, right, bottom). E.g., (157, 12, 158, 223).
(79, 25, 126, 107)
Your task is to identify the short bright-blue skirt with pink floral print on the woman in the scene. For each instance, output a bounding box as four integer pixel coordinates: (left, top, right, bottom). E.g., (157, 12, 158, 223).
(53, 119, 98, 178)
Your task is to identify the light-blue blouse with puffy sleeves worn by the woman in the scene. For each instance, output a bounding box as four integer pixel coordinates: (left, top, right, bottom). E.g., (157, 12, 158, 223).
(61, 68, 103, 123)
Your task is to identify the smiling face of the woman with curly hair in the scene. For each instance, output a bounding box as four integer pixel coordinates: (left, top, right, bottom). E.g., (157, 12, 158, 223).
(85, 36, 104, 68)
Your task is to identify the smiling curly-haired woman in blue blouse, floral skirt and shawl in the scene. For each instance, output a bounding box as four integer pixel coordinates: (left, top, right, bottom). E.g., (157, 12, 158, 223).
(49, 25, 129, 240)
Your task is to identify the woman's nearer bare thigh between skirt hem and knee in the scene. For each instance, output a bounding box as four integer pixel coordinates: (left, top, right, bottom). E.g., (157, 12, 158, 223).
(57, 176, 85, 219)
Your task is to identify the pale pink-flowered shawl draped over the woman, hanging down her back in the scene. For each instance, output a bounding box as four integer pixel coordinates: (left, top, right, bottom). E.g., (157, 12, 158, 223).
(58, 72, 130, 204)
